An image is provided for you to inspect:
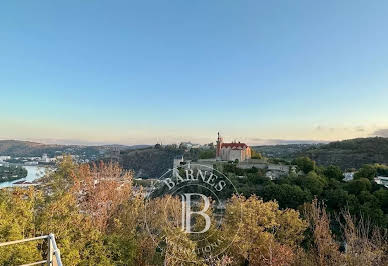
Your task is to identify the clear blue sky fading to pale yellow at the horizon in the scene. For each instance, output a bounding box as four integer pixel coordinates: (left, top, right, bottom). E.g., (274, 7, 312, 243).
(0, 0, 388, 145)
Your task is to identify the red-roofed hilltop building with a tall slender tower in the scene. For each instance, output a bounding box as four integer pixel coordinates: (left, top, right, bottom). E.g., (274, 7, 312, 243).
(216, 132, 251, 162)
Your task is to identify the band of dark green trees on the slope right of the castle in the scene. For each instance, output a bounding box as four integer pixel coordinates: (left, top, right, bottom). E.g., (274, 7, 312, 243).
(224, 157, 388, 228)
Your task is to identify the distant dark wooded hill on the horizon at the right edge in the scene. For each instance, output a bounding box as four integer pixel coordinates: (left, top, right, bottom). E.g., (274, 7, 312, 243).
(299, 137, 388, 169)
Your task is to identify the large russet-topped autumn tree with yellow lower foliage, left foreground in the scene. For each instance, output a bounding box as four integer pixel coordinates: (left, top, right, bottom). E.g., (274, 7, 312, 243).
(37, 157, 132, 265)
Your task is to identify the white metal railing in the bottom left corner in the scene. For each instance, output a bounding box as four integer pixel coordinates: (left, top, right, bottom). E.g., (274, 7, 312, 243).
(0, 234, 62, 266)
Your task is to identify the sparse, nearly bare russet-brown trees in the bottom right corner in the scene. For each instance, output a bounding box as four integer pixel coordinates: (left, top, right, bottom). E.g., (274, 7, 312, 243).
(295, 199, 388, 266)
